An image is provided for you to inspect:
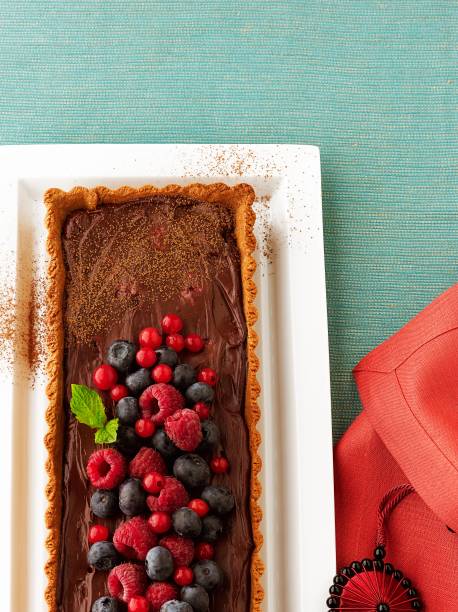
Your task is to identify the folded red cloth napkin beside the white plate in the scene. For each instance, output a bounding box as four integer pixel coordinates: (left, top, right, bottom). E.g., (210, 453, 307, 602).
(334, 285, 458, 612)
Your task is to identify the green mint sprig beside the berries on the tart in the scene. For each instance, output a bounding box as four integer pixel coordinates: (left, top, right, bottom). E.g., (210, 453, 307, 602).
(70, 385, 119, 444)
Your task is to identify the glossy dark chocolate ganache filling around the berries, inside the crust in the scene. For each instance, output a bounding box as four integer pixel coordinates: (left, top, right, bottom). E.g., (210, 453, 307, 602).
(58, 195, 253, 612)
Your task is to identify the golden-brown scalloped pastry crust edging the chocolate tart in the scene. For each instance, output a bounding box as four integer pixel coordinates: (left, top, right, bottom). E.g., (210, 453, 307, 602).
(44, 183, 264, 612)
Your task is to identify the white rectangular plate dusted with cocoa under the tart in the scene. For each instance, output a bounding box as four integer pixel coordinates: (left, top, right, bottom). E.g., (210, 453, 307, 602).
(0, 145, 335, 612)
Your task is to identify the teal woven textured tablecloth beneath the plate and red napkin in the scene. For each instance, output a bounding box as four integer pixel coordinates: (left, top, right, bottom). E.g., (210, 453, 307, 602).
(0, 0, 458, 438)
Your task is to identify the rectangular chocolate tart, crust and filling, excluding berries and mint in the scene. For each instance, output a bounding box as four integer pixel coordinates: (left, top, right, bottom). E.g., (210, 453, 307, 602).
(45, 183, 263, 612)
